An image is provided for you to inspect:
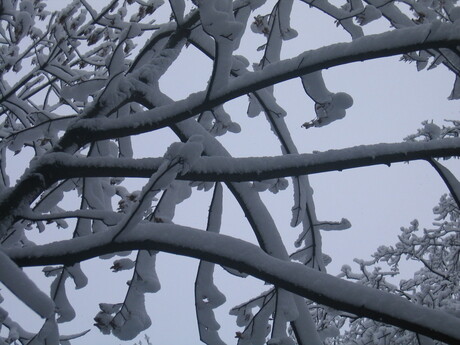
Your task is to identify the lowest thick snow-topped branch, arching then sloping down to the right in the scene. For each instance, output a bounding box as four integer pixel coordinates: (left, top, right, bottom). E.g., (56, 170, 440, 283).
(5, 223, 460, 344)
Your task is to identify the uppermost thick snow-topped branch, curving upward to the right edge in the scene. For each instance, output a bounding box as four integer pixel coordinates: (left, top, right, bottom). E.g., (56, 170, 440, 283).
(62, 23, 460, 146)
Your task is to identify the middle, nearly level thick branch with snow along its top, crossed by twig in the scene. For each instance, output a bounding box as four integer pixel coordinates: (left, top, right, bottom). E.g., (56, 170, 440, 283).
(37, 138, 460, 182)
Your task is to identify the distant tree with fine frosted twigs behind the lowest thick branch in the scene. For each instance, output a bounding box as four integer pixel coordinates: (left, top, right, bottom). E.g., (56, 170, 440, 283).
(311, 195, 460, 345)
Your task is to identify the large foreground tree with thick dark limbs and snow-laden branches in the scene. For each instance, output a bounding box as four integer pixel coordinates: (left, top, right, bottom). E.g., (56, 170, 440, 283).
(0, 0, 460, 345)
